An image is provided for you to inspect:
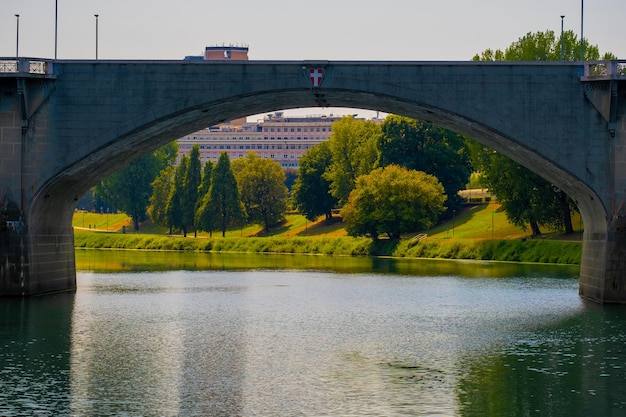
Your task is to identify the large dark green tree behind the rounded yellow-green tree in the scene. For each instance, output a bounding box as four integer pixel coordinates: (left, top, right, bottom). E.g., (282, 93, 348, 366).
(378, 115, 472, 211)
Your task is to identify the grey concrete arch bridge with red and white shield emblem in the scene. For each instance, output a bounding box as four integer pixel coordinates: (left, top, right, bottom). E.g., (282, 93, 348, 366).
(0, 58, 626, 303)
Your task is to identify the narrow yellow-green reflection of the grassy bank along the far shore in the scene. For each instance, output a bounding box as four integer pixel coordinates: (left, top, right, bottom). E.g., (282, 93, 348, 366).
(76, 250, 579, 277)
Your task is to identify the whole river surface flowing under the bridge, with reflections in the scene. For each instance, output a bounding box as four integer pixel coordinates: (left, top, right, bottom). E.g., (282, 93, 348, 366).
(0, 252, 626, 417)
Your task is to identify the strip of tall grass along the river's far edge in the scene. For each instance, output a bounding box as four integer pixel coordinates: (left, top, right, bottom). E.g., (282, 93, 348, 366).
(75, 231, 581, 265)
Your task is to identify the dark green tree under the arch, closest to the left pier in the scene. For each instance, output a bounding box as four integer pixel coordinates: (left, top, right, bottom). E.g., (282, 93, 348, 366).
(96, 152, 159, 231)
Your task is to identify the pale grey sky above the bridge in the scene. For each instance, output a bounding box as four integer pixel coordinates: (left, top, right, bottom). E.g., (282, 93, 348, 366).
(0, 0, 626, 117)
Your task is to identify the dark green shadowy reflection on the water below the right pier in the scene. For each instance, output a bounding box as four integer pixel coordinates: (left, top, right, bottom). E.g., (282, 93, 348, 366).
(457, 303, 626, 417)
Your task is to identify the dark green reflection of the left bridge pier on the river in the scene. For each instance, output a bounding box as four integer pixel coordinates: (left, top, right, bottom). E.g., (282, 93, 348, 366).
(0, 294, 74, 416)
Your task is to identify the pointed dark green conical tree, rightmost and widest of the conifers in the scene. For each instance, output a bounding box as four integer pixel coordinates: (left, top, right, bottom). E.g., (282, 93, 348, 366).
(198, 152, 243, 237)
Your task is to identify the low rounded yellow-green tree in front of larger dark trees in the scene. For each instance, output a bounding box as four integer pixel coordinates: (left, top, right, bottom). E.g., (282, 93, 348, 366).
(341, 165, 446, 239)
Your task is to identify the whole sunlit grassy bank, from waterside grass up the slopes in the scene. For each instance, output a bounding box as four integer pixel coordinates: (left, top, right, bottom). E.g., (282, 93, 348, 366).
(74, 204, 581, 264)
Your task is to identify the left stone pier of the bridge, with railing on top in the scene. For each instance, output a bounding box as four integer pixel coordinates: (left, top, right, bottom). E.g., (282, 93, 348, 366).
(0, 63, 76, 296)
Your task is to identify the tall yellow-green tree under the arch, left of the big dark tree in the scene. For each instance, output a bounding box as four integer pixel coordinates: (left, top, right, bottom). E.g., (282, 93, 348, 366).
(324, 116, 381, 205)
